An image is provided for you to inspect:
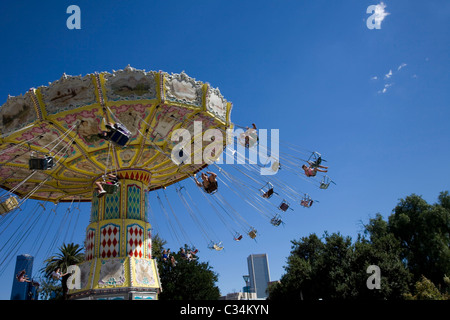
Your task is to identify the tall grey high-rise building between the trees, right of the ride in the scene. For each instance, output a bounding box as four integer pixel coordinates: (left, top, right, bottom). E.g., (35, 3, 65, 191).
(247, 253, 270, 299)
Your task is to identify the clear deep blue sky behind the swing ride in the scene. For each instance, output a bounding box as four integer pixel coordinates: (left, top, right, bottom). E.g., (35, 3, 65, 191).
(0, 0, 450, 299)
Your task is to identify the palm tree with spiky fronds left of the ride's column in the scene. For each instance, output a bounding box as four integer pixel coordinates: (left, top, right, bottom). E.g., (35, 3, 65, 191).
(42, 243, 84, 300)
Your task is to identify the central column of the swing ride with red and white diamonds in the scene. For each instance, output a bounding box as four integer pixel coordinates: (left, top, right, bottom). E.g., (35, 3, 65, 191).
(69, 170, 161, 300)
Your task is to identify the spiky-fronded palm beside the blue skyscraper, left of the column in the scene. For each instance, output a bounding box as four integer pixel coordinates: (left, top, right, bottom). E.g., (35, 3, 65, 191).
(41, 243, 84, 300)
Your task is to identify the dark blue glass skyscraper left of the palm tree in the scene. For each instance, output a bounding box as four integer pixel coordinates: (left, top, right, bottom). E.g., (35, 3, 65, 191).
(11, 254, 36, 300)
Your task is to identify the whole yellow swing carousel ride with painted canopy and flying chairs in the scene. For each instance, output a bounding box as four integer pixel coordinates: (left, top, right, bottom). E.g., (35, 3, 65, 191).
(0, 66, 334, 299)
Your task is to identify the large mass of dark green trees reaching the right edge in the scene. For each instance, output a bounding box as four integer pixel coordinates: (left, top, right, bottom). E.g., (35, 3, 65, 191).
(269, 191, 450, 300)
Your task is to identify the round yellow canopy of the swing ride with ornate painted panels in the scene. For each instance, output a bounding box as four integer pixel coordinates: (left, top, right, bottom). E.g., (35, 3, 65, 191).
(0, 66, 232, 202)
